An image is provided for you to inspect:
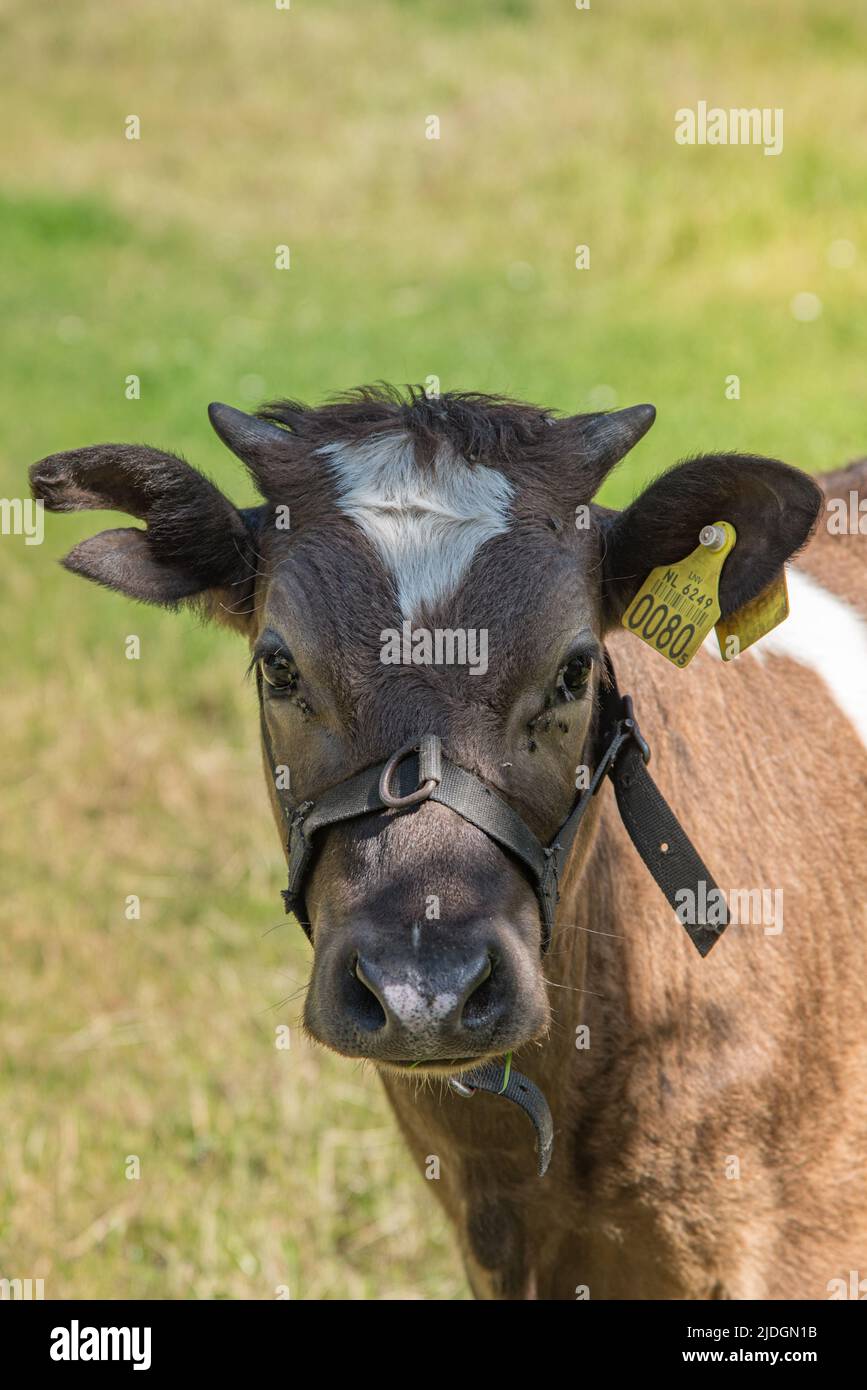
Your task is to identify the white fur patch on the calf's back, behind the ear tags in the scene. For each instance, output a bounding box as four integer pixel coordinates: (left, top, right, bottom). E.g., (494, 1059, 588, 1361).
(704, 569, 867, 745)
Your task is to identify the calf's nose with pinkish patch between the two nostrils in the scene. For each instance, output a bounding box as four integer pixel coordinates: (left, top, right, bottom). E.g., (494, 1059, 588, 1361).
(354, 951, 493, 1041)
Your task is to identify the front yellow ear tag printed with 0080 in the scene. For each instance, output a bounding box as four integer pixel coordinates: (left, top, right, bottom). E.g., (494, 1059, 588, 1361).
(621, 521, 738, 667)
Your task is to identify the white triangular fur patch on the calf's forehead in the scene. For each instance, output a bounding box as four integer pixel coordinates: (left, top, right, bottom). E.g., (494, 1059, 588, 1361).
(318, 434, 514, 619)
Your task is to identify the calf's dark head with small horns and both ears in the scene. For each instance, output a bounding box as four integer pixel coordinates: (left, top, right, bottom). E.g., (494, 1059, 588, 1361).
(31, 389, 820, 1070)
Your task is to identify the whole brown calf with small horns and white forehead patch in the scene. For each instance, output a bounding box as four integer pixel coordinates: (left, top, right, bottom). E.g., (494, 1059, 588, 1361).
(32, 389, 867, 1298)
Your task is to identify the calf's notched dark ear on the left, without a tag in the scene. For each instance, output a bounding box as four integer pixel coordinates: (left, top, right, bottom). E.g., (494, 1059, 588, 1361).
(31, 443, 258, 626)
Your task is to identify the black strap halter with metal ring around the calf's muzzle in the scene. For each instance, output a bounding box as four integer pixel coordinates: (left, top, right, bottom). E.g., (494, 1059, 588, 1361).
(257, 655, 728, 956)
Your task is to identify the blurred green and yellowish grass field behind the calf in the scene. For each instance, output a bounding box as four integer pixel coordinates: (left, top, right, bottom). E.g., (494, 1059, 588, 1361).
(0, 0, 867, 1298)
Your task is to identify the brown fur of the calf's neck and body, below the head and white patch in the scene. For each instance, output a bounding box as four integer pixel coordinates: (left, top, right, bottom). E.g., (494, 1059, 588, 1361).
(386, 608, 867, 1298)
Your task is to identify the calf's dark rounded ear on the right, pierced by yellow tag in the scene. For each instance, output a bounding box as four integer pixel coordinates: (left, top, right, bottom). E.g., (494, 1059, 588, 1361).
(597, 453, 823, 626)
